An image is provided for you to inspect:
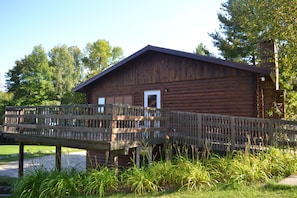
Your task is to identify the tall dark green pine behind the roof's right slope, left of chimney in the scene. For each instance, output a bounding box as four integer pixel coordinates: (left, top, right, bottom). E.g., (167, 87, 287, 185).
(209, 0, 259, 65)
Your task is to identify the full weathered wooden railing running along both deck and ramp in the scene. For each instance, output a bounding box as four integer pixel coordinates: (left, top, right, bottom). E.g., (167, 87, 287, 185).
(4, 104, 297, 151)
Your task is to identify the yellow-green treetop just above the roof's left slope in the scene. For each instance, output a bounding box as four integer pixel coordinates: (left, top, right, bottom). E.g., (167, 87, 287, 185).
(82, 40, 123, 77)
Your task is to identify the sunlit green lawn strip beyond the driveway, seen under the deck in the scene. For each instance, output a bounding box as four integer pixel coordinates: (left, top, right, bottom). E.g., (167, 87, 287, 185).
(0, 145, 82, 165)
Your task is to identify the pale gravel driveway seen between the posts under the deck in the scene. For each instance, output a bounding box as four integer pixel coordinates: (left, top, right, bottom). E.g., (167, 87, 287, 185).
(0, 151, 86, 177)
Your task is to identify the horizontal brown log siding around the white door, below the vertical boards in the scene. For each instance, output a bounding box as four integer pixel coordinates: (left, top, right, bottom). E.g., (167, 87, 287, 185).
(90, 76, 256, 117)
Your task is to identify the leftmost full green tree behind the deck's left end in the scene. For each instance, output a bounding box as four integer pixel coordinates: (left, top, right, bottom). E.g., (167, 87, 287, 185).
(6, 45, 54, 105)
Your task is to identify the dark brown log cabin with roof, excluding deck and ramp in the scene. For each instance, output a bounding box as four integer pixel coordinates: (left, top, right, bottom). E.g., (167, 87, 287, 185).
(74, 45, 284, 167)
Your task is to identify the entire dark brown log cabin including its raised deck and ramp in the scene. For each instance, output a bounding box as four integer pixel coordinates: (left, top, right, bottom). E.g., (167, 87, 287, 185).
(3, 42, 290, 175)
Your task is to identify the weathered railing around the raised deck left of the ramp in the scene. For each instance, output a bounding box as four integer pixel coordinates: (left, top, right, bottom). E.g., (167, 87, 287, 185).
(4, 104, 167, 145)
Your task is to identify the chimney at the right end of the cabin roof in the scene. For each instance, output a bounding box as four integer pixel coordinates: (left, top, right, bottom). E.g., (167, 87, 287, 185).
(260, 40, 279, 90)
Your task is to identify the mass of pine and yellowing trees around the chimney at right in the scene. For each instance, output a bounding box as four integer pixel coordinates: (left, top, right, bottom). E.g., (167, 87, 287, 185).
(210, 0, 297, 118)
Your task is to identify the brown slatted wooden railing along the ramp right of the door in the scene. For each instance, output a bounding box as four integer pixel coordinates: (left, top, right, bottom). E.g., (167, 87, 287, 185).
(169, 111, 297, 151)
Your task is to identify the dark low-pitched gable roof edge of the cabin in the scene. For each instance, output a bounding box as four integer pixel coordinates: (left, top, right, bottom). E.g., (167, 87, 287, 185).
(73, 45, 270, 92)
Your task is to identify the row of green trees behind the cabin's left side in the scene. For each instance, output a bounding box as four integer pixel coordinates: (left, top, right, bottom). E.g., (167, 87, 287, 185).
(0, 40, 123, 107)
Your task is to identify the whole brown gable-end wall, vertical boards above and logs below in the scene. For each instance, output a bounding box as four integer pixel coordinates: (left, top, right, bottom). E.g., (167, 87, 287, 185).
(87, 52, 259, 117)
